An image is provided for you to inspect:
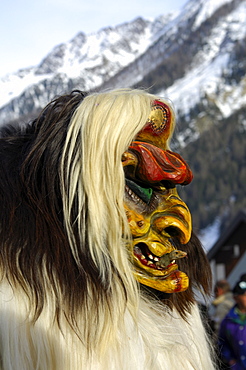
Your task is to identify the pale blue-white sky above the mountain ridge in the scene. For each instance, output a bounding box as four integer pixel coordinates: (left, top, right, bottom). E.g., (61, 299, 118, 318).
(0, 0, 187, 77)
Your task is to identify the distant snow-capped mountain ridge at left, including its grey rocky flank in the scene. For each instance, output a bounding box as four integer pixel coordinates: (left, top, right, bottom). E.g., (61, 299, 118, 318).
(0, 15, 172, 124)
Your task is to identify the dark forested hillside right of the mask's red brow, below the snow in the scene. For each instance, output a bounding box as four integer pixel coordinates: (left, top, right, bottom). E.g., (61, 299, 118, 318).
(179, 108, 246, 231)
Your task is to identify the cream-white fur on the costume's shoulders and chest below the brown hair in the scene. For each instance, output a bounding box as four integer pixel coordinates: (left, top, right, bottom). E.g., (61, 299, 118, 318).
(0, 286, 215, 370)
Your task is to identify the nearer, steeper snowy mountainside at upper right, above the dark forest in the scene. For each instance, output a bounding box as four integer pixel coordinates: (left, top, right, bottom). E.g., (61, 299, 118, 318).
(98, 0, 246, 146)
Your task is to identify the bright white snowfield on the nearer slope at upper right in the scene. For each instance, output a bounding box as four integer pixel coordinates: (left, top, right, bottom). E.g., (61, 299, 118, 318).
(160, 0, 246, 117)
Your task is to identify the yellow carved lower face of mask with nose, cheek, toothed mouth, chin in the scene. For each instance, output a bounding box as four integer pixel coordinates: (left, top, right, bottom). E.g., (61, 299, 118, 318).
(125, 189, 191, 293)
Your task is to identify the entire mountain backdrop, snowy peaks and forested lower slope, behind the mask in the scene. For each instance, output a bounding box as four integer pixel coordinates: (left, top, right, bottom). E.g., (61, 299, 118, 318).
(0, 0, 246, 247)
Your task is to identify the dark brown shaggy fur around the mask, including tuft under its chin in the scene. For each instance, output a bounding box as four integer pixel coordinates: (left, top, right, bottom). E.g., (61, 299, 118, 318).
(0, 91, 211, 325)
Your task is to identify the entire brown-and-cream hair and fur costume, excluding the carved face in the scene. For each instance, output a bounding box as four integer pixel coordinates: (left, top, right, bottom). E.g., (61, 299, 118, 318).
(0, 89, 215, 370)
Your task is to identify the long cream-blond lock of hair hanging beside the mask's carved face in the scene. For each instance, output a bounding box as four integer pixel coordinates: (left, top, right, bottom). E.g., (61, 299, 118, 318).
(60, 89, 160, 352)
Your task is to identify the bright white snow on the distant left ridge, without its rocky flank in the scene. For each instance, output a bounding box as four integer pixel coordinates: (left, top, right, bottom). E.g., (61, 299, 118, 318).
(0, 18, 160, 111)
